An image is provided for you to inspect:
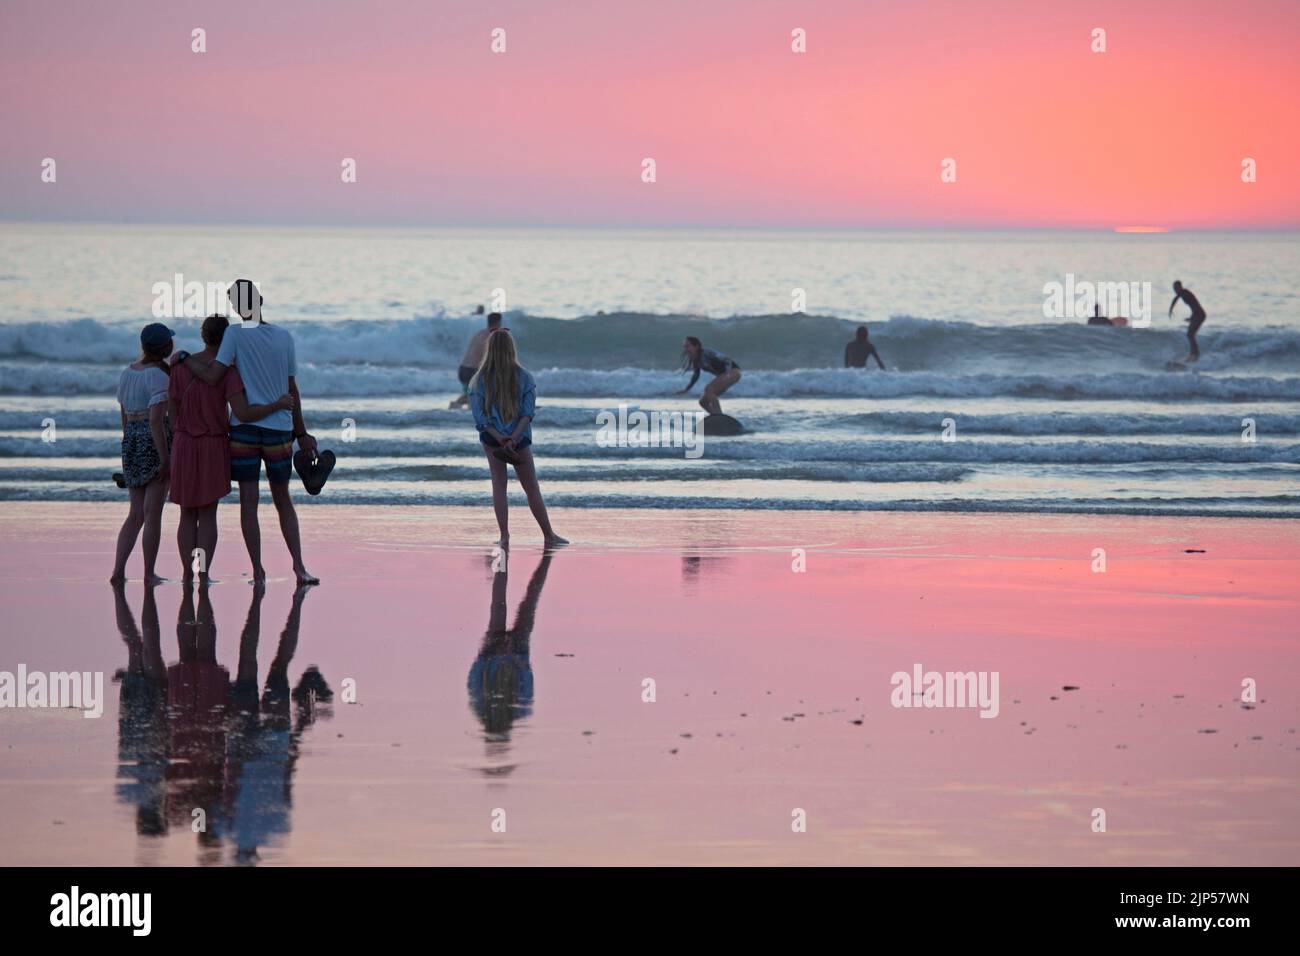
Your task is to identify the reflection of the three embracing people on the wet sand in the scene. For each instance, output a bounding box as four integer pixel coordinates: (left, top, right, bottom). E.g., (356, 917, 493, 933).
(113, 585, 333, 865)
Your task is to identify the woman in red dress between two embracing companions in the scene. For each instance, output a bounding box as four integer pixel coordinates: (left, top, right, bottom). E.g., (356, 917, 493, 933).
(168, 315, 294, 583)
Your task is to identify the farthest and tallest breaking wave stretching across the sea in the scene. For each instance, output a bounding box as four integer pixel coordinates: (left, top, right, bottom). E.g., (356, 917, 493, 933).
(0, 312, 1300, 376)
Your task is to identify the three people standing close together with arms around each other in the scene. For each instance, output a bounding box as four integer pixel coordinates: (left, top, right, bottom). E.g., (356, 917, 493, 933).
(112, 278, 316, 584)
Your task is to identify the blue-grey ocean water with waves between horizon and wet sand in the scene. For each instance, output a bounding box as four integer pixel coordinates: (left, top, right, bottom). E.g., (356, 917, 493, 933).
(0, 225, 1300, 515)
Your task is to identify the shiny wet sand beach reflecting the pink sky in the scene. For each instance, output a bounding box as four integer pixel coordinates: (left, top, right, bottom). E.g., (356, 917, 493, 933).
(0, 502, 1300, 865)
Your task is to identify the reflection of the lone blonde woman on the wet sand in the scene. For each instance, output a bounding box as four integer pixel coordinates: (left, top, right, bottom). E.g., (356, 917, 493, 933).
(467, 551, 551, 775)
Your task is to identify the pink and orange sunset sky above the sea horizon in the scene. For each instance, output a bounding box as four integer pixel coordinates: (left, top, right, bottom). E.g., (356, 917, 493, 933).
(0, 0, 1300, 229)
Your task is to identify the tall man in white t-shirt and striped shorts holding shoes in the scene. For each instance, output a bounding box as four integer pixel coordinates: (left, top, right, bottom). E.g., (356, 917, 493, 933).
(183, 278, 320, 584)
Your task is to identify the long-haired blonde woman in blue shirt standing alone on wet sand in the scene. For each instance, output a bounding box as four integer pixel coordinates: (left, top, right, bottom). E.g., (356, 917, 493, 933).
(469, 326, 568, 548)
